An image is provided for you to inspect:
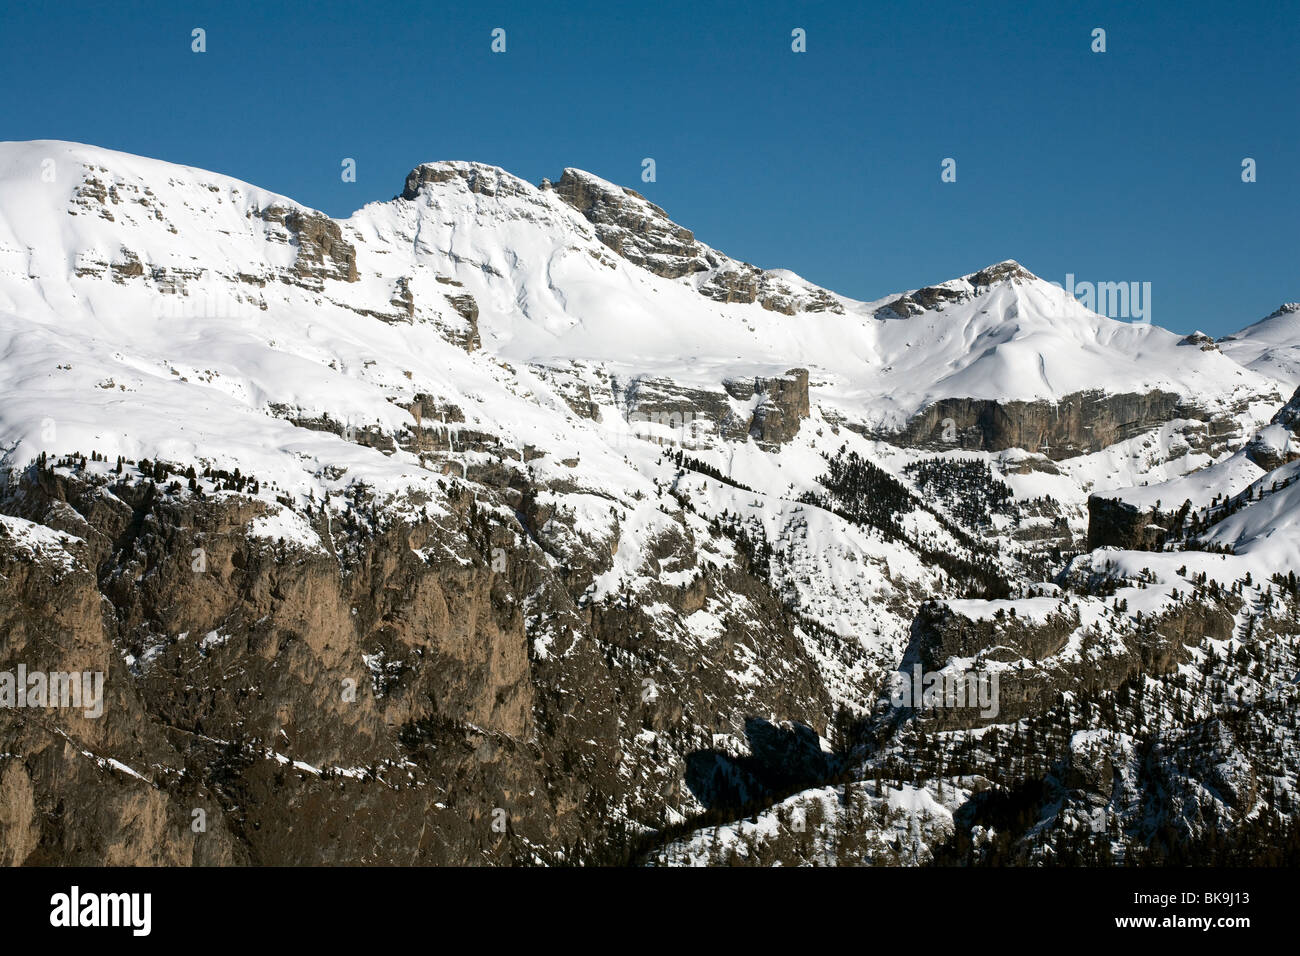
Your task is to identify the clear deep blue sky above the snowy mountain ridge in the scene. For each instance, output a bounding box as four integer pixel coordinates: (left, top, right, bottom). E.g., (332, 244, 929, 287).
(0, 0, 1300, 334)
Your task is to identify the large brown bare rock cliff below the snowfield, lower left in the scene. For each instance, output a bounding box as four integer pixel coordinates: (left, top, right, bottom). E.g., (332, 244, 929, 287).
(0, 471, 828, 864)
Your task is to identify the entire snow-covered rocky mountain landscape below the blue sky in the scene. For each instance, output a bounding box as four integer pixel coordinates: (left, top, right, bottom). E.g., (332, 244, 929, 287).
(0, 142, 1300, 866)
